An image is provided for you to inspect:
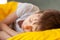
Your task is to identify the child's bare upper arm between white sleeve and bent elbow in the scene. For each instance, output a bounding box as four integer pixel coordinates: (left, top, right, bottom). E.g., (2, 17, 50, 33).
(2, 12, 18, 25)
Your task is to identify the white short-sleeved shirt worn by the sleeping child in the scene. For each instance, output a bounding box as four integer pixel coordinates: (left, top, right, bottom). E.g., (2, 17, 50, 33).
(15, 3, 40, 32)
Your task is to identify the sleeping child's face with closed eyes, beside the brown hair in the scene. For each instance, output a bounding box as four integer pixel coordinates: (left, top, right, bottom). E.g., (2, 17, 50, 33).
(22, 14, 41, 32)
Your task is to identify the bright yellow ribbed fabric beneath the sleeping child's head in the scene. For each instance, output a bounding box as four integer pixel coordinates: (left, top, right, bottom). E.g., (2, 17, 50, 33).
(7, 29, 60, 40)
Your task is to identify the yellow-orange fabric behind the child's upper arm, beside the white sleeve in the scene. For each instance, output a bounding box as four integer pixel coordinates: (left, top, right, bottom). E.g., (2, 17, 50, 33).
(0, 2, 17, 21)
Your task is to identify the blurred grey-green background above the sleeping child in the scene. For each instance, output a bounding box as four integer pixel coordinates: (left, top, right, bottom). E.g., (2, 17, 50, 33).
(8, 0, 60, 10)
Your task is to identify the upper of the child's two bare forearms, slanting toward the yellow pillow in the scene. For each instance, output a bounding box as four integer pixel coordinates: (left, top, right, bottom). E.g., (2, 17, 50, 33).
(0, 24, 17, 36)
